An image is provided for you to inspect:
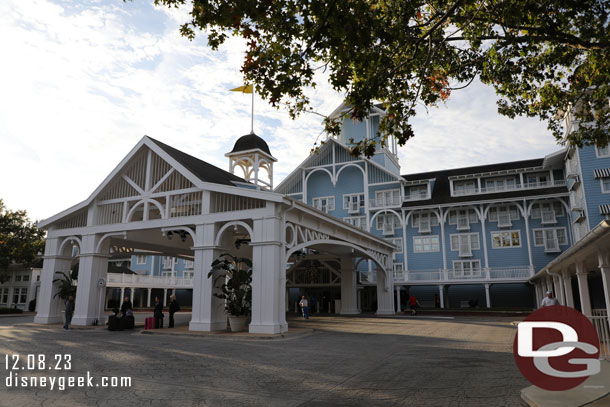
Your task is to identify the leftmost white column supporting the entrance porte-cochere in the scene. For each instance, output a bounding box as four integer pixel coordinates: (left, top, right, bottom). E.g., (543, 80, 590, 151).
(34, 238, 72, 324)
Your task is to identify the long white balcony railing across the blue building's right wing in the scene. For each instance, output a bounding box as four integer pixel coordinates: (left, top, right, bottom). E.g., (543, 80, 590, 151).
(394, 266, 534, 285)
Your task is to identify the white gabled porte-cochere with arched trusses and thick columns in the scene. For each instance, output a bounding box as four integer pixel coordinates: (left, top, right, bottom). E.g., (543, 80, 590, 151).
(35, 137, 394, 333)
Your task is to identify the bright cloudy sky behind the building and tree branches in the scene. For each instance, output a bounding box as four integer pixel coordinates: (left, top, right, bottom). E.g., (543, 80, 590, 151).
(0, 0, 561, 220)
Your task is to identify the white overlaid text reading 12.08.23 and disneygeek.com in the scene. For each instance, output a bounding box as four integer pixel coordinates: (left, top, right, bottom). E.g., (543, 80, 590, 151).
(4, 354, 131, 391)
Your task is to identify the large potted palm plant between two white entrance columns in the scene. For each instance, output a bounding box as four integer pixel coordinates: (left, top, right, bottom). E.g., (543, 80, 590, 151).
(208, 253, 252, 332)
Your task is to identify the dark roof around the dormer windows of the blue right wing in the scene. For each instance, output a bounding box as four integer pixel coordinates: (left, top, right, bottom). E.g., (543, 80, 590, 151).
(402, 158, 568, 208)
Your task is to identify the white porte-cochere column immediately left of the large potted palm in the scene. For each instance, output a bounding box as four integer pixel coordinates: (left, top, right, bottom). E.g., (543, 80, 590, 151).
(189, 224, 227, 331)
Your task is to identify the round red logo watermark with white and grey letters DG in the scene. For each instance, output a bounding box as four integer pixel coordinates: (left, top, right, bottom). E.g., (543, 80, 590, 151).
(513, 305, 600, 391)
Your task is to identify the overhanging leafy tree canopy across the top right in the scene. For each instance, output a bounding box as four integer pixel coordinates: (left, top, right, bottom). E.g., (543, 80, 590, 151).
(155, 0, 610, 155)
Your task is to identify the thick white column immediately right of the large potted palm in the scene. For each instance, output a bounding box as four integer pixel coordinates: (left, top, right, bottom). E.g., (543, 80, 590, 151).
(249, 217, 283, 334)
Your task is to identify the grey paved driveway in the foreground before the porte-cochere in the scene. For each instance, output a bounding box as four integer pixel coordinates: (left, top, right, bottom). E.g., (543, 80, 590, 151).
(0, 317, 528, 407)
